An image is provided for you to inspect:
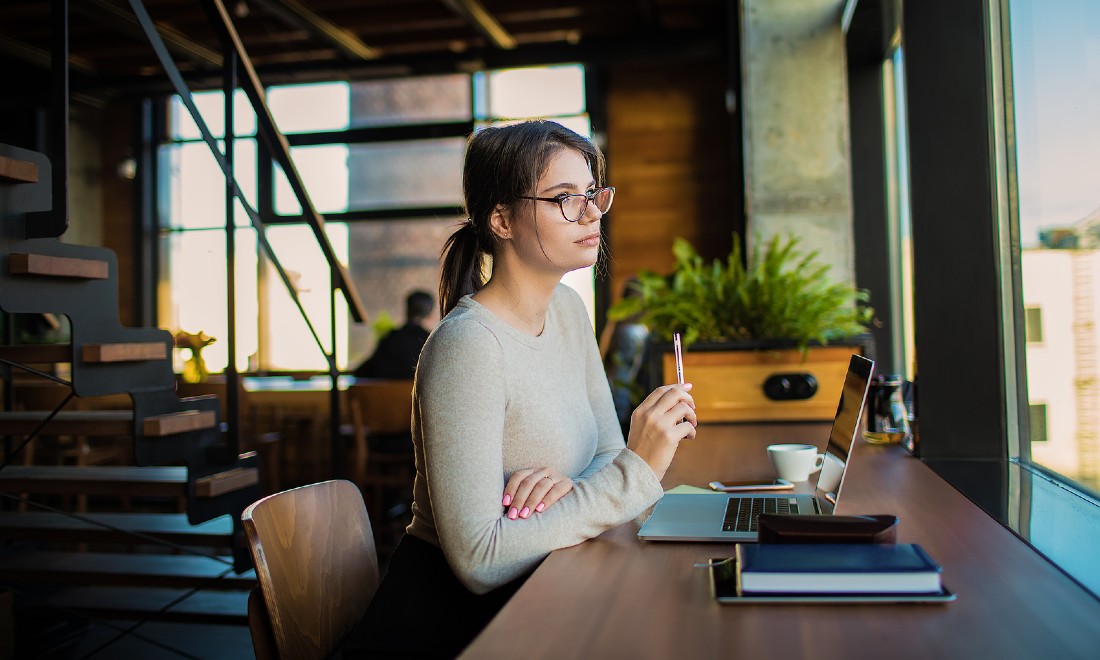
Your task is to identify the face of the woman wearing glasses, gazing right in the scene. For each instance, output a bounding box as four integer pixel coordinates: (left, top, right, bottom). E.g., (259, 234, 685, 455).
(512, 149, 603, 274)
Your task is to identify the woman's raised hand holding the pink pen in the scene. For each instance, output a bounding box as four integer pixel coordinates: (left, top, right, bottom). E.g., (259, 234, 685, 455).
(626, 383, 697, 481)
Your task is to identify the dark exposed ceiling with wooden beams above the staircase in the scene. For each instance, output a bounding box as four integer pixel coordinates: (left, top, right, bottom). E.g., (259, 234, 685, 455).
(0, 0, 727, 96)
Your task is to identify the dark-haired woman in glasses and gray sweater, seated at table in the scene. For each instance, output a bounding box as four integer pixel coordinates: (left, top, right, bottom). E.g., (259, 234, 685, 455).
(345, 121, 695, 657)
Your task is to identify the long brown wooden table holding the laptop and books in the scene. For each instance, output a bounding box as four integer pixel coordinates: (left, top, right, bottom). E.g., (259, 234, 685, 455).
(463, 425, 1100, 660)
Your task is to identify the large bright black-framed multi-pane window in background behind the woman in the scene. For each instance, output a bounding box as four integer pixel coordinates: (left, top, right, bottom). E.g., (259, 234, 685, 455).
(158, 65, 595, 372)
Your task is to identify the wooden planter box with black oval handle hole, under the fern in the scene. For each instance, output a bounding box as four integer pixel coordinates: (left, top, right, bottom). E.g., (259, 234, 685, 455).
(649, 334, 875, 422)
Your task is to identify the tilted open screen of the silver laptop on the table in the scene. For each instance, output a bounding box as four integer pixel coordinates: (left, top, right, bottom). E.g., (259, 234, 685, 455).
(815, 354, 875, 514)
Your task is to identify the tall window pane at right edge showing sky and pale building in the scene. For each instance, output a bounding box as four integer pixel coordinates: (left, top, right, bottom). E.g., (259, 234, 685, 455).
(1011, 0, 1100, 490)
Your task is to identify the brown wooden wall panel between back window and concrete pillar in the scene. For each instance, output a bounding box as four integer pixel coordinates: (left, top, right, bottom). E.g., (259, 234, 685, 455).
(607, 59, 743, 300)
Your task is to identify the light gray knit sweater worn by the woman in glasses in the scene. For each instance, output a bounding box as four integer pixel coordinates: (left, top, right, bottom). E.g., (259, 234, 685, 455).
(408, 285, 662, 593)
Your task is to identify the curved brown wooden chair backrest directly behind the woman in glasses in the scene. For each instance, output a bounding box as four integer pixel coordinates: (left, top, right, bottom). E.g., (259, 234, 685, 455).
(241, 480, 380, 660)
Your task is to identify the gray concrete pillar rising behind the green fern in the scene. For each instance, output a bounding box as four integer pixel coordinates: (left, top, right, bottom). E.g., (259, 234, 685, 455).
(740, 0, 855, 282)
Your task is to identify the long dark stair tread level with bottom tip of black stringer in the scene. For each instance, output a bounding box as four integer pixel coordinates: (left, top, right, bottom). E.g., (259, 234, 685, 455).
(0, 512, 233, 546)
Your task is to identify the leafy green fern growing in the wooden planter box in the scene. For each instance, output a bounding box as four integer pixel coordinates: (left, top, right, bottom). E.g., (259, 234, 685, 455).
(608, 234, 873, 351)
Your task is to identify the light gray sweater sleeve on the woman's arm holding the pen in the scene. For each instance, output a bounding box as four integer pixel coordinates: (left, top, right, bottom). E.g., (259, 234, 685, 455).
(415, 312, 662, 593)
